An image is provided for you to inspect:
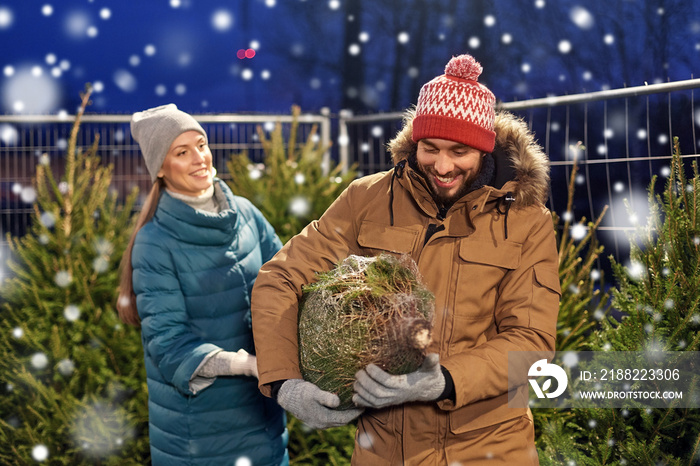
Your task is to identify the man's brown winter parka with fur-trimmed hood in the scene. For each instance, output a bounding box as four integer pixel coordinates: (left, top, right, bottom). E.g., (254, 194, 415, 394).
(252, 112, 561, 465)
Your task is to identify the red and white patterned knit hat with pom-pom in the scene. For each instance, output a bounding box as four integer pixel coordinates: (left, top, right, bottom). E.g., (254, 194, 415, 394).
(413, 54, 496, 152)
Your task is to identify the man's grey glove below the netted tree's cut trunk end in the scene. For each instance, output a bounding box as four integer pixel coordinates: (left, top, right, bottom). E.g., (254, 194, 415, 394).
(352, 353, 445, 408)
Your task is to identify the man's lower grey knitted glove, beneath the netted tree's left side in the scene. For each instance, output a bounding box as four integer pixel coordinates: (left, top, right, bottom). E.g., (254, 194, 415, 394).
(277, 379, 364, 429)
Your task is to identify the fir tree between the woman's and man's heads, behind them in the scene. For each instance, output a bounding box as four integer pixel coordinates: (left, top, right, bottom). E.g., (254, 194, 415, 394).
(227, 106, 357, 243)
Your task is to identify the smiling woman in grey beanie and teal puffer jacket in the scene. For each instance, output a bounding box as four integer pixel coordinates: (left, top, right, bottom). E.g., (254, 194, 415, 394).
(117, 104, 288, 466)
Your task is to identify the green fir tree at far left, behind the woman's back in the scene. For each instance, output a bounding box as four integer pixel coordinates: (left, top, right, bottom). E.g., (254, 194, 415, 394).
(0, 87, 149, 465)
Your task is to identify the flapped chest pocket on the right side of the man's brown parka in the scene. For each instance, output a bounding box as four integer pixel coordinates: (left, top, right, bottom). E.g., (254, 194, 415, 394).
(454, 239, 522, 319)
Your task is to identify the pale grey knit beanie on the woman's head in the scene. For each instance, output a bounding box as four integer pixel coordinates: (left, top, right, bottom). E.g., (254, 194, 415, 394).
(131, 104, 207, 182)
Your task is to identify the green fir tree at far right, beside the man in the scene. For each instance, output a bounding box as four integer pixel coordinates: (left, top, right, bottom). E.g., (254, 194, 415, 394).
(538, 139, 700, 465)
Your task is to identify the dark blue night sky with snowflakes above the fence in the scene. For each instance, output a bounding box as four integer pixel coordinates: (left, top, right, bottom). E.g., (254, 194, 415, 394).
(0, 0, 700, 113)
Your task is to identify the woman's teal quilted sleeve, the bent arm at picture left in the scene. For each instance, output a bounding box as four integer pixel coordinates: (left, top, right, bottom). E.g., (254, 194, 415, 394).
(132, 235, 219, 395)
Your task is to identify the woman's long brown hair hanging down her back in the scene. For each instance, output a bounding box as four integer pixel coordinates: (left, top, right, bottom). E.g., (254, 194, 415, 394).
(117, 178, 165, 327)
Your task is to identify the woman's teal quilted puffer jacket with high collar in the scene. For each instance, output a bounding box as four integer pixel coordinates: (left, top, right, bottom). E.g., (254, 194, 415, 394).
(131, 179, 288, 466)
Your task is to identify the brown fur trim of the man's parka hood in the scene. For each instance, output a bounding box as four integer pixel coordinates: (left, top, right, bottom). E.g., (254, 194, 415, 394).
(388, 109, 549, 207)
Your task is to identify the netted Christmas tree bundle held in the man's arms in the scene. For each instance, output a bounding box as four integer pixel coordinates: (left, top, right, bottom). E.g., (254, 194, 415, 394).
(299, 254, 434, 409)
